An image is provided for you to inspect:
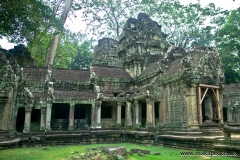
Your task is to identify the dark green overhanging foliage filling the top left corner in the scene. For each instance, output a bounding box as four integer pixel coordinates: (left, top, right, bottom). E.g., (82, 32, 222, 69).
(0, 0, 58, 43)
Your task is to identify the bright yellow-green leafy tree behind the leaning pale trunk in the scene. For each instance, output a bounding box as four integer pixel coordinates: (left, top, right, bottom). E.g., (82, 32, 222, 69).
(27, 31, 87, 68)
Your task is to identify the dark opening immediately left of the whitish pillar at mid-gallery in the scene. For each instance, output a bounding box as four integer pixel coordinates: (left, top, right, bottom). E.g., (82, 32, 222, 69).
(74, 104, 92, 130)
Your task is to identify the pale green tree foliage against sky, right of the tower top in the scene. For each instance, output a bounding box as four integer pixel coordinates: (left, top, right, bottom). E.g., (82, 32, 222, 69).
(142, 0, 223, 48)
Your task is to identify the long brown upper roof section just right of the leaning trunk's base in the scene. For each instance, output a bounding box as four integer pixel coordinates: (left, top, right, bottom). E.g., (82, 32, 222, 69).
(52, 69, 90, 82)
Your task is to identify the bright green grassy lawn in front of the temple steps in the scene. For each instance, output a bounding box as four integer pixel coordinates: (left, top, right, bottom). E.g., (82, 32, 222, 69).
(0, 143, 237, 160)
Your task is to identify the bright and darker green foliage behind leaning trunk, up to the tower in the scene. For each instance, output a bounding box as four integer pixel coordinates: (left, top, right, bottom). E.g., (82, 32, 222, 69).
(28, 32, 92, 69)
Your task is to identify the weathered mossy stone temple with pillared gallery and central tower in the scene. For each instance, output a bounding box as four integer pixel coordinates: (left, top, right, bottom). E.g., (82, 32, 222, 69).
(0, 13, 240, 153)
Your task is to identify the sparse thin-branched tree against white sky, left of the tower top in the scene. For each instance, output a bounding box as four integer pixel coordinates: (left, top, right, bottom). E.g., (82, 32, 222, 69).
(75, 0, 141, 38)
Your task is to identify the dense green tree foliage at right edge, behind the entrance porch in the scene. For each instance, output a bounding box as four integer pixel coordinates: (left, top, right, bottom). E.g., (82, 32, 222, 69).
(216, 10, 240, 83)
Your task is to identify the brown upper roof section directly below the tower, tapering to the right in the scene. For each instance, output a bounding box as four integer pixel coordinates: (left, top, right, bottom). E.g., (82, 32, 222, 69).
(92, 66, 131, 80)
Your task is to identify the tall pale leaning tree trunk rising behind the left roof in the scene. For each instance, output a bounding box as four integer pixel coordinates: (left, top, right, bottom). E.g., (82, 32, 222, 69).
(45, 0, 73, 66)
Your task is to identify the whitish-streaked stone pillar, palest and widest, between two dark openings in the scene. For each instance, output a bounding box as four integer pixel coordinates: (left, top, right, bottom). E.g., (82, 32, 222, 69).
(92, 100, 102, 128)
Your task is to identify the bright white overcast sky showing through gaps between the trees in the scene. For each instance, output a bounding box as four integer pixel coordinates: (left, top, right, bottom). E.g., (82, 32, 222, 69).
(0, 0, 240, 49)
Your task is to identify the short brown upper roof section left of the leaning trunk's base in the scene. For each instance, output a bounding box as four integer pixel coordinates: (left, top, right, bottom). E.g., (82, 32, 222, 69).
(23, 68, 47, 82)
